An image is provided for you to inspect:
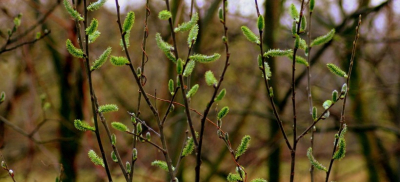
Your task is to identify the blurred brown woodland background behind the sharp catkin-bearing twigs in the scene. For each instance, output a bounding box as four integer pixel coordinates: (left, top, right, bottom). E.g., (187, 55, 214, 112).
(0, 0, 400, 182)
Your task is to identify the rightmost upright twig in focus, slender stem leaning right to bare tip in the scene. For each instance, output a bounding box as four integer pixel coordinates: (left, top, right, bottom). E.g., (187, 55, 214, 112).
(325, 14, 361, 182)
